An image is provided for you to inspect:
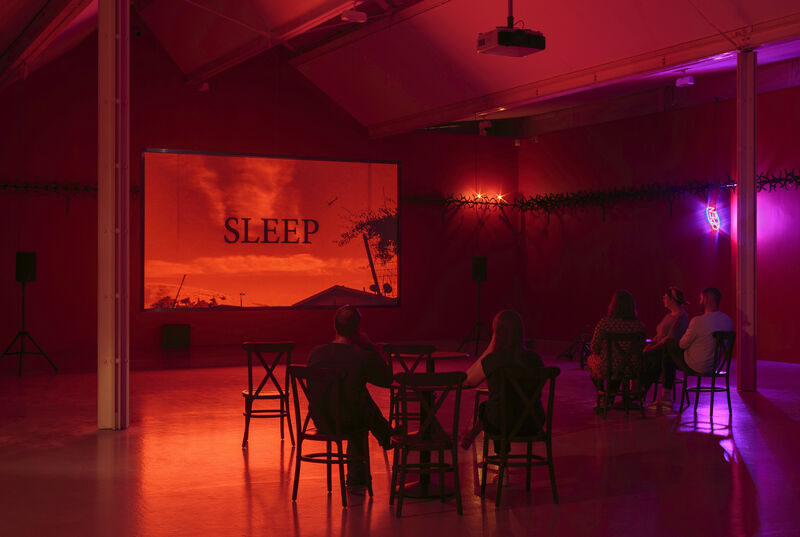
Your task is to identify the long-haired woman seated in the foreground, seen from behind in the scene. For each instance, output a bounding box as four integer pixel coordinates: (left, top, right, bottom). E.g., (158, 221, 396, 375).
(461, 310, 545, 449)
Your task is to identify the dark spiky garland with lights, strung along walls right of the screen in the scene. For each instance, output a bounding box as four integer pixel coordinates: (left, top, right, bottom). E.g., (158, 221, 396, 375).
(406, 169, 800, 214)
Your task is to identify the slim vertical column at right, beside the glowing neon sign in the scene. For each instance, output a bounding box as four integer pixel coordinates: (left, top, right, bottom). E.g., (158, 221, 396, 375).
(735, 50, 756, 391)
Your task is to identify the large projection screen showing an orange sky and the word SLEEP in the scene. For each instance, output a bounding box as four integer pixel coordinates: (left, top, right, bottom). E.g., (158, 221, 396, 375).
(142, 149, 399, 310)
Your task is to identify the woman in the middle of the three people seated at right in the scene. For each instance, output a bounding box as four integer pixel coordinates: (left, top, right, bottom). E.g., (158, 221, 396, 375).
(643, 287, 689, 407)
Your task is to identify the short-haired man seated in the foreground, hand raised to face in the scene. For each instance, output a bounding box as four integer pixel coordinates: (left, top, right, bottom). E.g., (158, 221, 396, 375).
(308, 306, 392, 486)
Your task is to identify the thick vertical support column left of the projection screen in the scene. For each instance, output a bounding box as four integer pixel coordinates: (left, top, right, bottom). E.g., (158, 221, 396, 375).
(97, 0, 130, 429)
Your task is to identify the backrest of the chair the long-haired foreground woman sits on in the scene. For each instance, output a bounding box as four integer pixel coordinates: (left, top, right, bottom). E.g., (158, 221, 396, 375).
(489, 367, 561, 440)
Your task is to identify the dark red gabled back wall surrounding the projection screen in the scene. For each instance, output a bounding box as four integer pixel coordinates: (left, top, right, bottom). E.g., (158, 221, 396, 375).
(0, 23, 521, 370)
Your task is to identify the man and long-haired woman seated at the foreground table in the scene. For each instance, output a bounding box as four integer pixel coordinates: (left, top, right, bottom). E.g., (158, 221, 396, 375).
(308, 306, 544, 487)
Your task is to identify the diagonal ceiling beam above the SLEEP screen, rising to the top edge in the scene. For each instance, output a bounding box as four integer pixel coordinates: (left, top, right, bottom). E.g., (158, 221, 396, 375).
(186, 0, 364, 84)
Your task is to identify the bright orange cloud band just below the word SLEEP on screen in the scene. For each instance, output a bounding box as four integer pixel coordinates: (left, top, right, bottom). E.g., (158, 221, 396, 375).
(145, 254, 366, 278)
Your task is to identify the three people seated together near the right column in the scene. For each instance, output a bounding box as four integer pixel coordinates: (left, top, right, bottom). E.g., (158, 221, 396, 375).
(587, 287, 733, 411)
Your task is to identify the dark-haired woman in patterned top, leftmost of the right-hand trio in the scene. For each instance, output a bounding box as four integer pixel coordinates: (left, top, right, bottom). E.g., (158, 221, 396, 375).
(586, 290, 644, 402)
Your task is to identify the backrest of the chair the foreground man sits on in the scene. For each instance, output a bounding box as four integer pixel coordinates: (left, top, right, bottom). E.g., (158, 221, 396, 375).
(289, 365, 347, 438)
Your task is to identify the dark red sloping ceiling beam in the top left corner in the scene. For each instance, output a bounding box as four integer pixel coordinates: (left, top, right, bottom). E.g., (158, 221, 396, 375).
(0, 0, 92, 90)
